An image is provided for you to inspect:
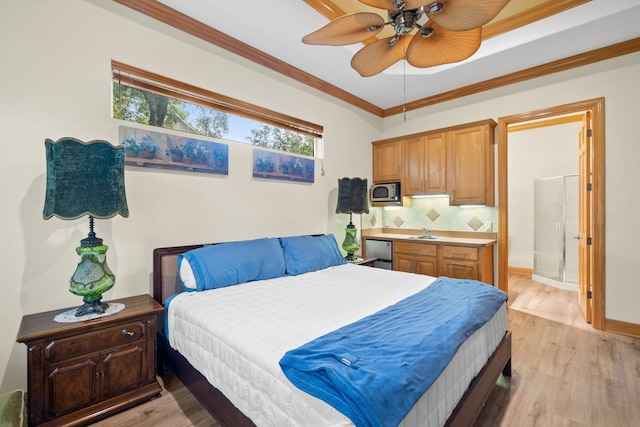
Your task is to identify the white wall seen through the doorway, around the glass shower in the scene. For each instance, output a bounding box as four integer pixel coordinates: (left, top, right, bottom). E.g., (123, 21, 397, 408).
(509, 122, 581, 269)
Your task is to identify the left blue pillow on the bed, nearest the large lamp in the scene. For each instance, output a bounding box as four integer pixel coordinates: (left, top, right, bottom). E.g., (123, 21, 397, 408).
(178, 238, 286, 291)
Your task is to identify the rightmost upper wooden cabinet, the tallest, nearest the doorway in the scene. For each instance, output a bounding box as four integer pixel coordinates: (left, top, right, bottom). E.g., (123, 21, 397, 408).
(447, 120, 496, 206)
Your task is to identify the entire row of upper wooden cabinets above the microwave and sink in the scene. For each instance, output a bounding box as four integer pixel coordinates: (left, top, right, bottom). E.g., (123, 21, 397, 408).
(373, 120, 496, 206)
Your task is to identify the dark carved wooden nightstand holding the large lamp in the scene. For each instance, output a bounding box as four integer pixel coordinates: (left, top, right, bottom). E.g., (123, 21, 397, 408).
(17, 295, 163, 426)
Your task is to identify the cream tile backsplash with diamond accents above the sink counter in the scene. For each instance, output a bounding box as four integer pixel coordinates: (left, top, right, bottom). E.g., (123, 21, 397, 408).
(361, 197, 498, 232)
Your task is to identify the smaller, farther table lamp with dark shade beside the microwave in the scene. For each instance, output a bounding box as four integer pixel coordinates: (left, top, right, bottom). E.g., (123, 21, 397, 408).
(336, 178, 369, 261)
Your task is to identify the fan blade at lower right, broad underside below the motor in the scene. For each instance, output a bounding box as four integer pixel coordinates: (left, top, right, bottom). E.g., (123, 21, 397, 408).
(407, 21, 482, 68)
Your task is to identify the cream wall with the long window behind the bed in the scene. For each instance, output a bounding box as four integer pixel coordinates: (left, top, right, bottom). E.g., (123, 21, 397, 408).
(0, 0, 381, 392)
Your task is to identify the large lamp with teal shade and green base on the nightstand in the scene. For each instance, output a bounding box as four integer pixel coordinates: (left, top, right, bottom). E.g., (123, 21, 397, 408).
(43, 137, 129, 317)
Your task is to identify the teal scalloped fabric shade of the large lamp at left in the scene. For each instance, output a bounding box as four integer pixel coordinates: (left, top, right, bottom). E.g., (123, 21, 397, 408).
(43, 138, 129, 219)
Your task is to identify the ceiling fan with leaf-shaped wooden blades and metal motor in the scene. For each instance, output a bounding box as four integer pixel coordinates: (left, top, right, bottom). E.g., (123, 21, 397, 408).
(302, 0, 509, 77)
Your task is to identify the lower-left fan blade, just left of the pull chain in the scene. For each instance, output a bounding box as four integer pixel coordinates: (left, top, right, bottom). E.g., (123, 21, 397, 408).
(351, 36, 408, 77)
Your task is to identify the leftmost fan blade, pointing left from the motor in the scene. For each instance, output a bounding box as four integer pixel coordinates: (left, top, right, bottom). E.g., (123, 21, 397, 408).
(302, 12, 385, 46)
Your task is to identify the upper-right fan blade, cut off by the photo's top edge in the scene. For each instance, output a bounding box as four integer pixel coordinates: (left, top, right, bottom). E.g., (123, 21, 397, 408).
(429, 0, 509, 31)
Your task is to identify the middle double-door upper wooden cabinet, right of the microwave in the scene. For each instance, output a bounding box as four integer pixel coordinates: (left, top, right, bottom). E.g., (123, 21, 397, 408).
(402, 132, 447, 196)
